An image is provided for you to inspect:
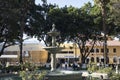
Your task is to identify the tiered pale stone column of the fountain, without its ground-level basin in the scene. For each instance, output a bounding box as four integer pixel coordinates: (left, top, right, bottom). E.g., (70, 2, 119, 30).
(44, 24, 63, 71)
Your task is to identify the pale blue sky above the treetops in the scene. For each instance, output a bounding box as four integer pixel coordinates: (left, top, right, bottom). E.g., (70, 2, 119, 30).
(35, 0, 93, 8)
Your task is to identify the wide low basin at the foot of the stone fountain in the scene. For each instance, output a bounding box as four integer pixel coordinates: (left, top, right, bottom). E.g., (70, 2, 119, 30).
(45, 70, 82, 80)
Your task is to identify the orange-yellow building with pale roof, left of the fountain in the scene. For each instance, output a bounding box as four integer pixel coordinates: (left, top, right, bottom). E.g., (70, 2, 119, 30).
(0, 43, 48, 65)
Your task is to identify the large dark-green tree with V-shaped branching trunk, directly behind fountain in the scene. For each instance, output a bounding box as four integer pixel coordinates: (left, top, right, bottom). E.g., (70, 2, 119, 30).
(27, 3, 100, 63)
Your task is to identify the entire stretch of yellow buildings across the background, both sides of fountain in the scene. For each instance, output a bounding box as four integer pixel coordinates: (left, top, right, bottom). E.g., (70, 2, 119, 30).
(0, 41, 120, 65)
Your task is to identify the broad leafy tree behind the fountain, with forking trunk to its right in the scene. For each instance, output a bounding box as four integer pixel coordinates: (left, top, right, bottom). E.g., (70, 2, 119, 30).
(25, 1, 114, 63)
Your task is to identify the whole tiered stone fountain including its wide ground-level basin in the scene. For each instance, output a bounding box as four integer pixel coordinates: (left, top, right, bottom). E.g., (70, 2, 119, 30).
(44, 24, 82, 80)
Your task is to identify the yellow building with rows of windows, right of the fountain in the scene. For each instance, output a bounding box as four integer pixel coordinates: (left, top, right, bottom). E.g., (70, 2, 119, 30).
(56, 40, 120, 64)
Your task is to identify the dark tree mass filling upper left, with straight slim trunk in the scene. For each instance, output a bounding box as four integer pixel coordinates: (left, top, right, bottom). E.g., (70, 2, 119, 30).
(0, 0, 35, 63)
